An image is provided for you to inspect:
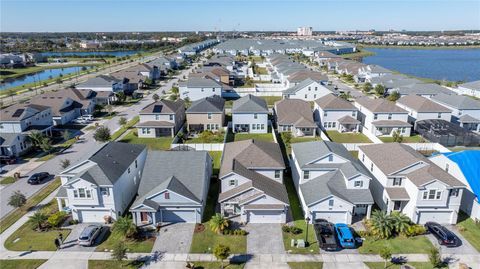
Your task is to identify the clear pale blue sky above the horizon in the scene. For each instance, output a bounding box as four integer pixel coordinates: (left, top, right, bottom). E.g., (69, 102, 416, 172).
(0, 0, 480, 32)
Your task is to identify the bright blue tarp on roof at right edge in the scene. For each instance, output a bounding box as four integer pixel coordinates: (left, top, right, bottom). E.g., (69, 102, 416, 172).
(442, 150, 480, 201)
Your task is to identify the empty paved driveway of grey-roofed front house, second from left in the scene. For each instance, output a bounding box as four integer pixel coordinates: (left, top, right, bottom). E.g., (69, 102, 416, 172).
(152, 223, 195, 253)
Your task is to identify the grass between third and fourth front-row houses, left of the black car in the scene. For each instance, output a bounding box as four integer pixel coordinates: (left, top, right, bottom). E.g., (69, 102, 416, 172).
(282, 176, 320, 254)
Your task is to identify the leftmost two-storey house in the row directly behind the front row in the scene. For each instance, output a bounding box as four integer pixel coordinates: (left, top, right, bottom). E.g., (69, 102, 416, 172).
(135, 100, 185, 138)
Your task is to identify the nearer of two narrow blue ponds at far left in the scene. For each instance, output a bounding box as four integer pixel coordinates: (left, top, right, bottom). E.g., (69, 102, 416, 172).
(0, 66, 91, 91)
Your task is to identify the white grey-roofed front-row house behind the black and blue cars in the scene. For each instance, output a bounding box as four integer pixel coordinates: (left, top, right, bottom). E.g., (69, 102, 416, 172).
(290, 141, 374, 224)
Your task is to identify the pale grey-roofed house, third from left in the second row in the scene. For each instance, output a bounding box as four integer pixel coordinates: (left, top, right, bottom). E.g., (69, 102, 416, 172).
(232, 94, 268, 133)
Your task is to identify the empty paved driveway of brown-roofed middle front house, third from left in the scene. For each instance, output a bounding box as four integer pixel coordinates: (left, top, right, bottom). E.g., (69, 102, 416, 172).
(245, 223, 285, 254)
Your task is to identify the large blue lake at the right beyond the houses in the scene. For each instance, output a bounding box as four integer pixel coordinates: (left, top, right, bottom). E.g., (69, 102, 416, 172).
(362, 48, 480, 82)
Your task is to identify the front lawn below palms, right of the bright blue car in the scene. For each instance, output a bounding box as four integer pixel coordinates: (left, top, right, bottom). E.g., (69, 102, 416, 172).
(358, 235, 433, 254)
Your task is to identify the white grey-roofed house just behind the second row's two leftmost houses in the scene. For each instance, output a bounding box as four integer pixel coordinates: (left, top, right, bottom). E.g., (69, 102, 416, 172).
(179, 76, 223, 101)
